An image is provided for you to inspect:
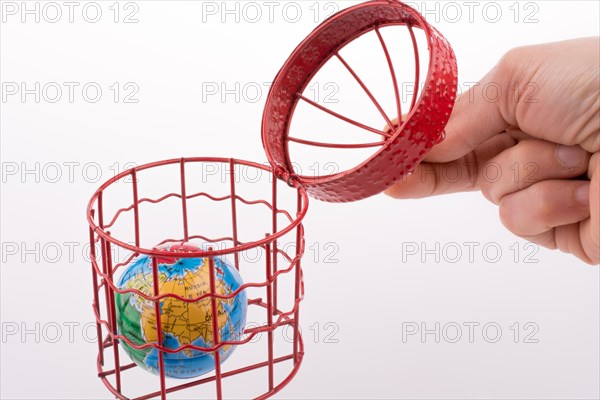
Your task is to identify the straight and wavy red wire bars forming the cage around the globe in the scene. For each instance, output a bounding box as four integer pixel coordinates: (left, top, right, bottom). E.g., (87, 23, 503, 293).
(87, 158, 308, 400)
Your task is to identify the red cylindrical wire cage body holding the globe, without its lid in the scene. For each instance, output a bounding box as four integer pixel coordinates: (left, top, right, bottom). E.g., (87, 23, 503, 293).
(88, 158, 308, 400)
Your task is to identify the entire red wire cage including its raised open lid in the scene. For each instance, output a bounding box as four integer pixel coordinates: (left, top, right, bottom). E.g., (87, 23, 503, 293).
(87, 0, 457, 400)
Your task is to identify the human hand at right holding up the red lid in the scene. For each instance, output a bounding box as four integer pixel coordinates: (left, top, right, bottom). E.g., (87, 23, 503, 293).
(386, 37, 600, 264)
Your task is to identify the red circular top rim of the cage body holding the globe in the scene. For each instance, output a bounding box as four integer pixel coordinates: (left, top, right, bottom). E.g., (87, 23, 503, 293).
(86, 157, 308, 258)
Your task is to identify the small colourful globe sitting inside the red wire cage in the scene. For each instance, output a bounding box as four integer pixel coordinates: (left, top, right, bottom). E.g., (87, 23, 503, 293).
(116, 243, 248, 379)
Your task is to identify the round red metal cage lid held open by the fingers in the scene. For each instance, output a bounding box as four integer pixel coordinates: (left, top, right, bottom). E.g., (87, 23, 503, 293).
(262, 0, 457, 202)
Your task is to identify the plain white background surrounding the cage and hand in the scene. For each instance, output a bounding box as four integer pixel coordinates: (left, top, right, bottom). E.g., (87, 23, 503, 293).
(0, 1, 600, 399)
